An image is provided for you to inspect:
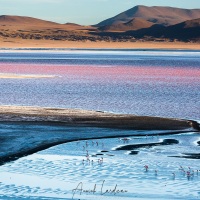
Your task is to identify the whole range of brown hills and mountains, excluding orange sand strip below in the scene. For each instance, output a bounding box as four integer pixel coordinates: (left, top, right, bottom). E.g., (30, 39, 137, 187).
(0, 10, 200, 42)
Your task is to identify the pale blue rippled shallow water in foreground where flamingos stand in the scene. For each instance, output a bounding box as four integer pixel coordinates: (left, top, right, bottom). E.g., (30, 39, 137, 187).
(0, 133, 200, 200)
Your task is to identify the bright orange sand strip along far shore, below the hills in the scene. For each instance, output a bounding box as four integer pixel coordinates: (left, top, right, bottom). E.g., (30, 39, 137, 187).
(0, 38, 200, 50)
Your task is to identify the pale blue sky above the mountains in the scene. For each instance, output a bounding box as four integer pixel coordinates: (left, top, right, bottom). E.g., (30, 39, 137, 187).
(0, 0, 200, 25)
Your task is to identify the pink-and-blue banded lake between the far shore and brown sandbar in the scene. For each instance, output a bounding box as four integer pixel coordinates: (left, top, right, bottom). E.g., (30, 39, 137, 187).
(0, 50, 200, 119)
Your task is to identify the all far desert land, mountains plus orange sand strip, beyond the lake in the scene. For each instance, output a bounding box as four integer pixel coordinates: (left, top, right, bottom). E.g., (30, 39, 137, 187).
(0, 6, 200, 49)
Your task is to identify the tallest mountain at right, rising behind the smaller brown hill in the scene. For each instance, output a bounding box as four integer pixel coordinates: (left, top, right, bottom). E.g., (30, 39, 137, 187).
(96, 6, 200, 27)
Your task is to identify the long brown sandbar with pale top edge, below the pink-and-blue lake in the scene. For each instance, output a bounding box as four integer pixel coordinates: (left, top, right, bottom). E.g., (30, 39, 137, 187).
(0, 106, 192, 130)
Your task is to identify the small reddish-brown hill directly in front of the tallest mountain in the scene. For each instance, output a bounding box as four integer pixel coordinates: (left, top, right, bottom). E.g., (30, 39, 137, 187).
(99, 18, 154, 32)
